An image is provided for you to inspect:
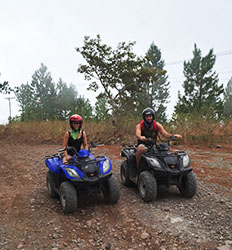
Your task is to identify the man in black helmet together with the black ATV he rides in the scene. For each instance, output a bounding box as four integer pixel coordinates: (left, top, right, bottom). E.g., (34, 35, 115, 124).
(120, 108, 197, 202)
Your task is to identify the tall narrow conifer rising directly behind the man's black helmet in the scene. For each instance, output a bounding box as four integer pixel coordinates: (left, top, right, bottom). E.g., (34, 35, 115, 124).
(138, 42, 170, 122)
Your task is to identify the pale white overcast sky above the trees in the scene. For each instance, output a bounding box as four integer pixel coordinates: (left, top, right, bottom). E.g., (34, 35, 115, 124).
(0, 0, 232, 123)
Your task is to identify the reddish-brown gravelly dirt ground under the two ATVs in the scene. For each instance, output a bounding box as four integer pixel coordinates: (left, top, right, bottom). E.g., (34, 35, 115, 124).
(0, 142, 232, 250)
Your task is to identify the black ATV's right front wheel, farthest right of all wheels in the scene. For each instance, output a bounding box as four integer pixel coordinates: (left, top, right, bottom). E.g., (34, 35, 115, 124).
(178, 172, 197, 198)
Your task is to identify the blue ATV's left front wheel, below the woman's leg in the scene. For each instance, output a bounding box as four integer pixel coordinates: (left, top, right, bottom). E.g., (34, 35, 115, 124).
(60, 181, 77, 213)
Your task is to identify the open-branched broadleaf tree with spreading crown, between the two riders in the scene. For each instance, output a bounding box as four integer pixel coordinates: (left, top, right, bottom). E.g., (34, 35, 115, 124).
(76, 35, 161, 124)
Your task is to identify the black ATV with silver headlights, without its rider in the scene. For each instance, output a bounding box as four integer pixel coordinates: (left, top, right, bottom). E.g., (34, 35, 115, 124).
(120, 136, 197, 202)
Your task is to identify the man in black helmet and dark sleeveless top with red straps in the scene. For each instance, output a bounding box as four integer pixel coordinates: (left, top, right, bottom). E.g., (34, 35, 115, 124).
(136, 108, 182, 166)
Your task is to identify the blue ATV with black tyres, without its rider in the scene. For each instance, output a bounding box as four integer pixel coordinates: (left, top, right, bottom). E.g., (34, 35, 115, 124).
(45, 147, 120, 213)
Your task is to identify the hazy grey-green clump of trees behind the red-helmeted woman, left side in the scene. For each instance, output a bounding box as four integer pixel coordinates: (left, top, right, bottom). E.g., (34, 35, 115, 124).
(16, 64, 92, 121)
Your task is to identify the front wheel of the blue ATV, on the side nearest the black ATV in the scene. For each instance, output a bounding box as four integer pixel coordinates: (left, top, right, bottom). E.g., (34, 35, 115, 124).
(102, 175, 120, 204)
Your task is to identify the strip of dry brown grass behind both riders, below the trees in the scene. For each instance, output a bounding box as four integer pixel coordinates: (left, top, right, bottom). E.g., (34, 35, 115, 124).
(0, 117, 232, 147)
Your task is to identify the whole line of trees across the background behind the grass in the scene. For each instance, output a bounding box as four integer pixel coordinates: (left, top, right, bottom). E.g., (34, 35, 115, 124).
(0, 35, 232, 122)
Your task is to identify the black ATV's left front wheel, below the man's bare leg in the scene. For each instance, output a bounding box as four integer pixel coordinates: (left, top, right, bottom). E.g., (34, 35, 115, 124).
(138, 171, 157, 202)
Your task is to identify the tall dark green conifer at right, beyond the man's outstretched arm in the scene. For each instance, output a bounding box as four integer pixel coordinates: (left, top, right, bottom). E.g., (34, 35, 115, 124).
(175, 44, 223, 118)
